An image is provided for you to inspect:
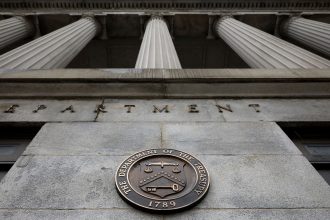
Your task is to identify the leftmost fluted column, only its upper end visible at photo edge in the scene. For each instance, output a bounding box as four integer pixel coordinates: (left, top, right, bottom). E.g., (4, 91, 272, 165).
(0, 16, 34, 49)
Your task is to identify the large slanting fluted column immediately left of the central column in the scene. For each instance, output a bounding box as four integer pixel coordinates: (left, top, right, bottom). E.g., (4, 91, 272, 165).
(0, 17, 99, 69)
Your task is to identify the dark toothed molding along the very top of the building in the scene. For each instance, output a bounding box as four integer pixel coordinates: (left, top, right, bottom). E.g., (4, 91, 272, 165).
(0, 0, 330, 11)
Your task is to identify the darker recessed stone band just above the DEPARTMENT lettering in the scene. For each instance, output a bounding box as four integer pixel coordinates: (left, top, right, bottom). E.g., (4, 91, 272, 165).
(0, 82, 330, 99)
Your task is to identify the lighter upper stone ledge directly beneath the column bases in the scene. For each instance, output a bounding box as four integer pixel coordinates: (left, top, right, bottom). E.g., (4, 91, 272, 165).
(0, 69, 330, 82)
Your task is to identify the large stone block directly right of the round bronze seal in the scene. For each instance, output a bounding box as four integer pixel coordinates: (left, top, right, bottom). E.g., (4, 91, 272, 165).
(198, 155, 330, 209)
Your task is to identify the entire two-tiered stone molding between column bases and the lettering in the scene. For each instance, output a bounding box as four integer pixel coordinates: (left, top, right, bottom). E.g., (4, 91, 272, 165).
(0, 69, 330, 99)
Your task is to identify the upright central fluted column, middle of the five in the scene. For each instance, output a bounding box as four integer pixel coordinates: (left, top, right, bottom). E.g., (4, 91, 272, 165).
(135, 17, 181, 69)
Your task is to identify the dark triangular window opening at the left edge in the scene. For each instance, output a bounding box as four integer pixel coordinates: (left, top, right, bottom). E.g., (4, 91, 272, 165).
(0, 124, 41, 180)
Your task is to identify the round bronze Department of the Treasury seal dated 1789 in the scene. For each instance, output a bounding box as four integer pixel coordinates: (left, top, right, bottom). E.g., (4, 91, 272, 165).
(116, 149, 210, 211)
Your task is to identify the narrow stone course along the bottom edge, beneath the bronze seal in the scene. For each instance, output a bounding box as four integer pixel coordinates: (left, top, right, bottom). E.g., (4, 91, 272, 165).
(0, 208, 330, 220)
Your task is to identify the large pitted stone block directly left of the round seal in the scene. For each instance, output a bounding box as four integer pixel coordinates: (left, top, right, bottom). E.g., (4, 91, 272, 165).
(0, 156, 129, 209)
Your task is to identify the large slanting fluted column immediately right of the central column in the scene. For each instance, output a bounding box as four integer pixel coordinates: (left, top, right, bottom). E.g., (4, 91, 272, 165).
(215, 17, 330, 69)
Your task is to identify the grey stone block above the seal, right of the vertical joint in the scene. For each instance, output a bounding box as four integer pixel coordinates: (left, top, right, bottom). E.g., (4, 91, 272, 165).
(162, 122, 301, 155)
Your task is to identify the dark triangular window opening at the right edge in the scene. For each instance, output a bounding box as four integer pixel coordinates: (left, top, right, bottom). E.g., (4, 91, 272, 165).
(282, 123, 330, 185)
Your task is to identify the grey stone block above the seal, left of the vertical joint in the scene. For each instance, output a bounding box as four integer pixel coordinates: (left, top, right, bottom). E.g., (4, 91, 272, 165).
(24, 122, 161, 156)
